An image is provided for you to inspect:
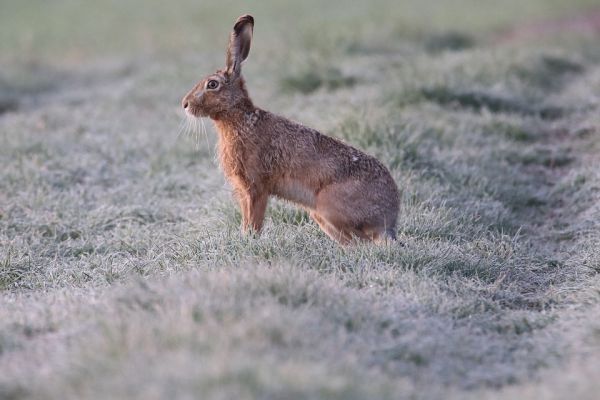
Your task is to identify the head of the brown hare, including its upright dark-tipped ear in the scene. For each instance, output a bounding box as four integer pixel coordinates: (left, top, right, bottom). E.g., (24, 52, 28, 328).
(181, 15, 254, 119)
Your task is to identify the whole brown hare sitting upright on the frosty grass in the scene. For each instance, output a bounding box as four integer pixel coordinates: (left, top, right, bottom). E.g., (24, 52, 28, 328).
(181, 15, 399, 244)
